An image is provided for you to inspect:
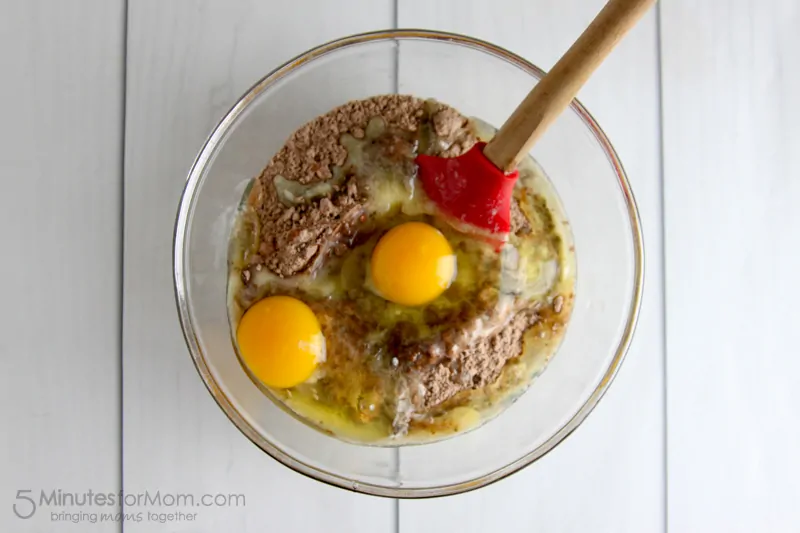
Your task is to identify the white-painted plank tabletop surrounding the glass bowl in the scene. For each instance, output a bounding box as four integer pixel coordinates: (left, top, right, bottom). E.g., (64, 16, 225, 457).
(0, 0, 800, 533)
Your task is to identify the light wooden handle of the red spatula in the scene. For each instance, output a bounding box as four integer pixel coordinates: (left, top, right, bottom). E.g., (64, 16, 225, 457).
(483, 0, 656, 172)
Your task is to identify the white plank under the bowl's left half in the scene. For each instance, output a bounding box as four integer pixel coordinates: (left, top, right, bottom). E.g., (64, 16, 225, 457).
(123, 0, 395, 533)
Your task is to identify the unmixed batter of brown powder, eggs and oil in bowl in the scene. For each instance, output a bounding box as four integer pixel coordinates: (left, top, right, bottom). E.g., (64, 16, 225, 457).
(228, 95, 575, 445)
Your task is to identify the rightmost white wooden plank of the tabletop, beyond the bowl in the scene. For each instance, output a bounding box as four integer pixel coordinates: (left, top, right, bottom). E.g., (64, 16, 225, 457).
(661, 0, 800, 533)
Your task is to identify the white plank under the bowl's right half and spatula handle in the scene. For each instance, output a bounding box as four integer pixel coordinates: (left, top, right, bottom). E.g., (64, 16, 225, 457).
(399, 0, 665, 533)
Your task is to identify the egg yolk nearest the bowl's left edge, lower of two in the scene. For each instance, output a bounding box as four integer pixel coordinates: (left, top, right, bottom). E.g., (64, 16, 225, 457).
(236, 296, 325, 389)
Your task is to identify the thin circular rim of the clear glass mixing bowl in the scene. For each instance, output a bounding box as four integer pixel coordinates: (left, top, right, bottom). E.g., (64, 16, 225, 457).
(173, 29, 644, 499)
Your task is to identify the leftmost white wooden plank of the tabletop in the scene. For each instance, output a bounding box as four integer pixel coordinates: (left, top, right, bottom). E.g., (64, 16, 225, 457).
(0, 0, 124, 532)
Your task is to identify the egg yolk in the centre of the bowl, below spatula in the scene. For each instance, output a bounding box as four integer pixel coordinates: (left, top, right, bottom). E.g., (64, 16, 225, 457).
(370, 222, 456, 306)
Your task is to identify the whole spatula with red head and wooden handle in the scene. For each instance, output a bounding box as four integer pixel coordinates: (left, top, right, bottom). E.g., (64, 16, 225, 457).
(416, 0, 656, 233)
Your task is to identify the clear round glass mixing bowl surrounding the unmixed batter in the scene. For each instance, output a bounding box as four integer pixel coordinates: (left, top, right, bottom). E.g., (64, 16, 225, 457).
(174, 30, 643, 498)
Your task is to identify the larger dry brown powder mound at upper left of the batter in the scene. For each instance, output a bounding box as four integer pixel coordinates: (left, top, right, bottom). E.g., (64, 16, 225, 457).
(249, 94, 476, 277)
